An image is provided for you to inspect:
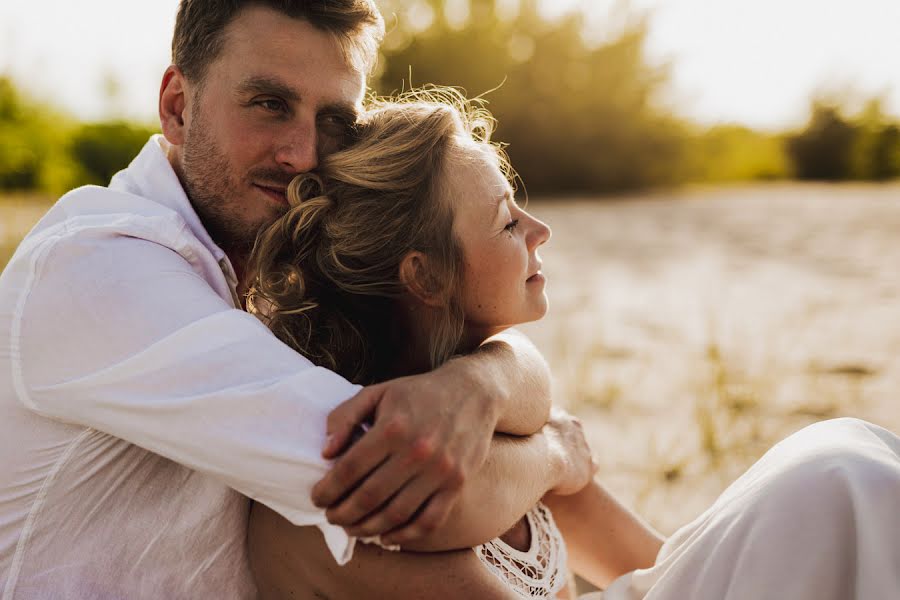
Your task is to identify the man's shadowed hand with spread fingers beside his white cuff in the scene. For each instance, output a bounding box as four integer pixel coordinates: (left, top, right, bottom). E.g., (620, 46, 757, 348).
(312, 361, 499, 544)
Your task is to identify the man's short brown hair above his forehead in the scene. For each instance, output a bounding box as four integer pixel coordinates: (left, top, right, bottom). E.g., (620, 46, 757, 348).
(172, 0, 384, 83)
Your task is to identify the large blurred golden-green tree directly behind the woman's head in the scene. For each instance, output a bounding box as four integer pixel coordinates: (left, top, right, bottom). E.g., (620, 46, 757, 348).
(375, 0, 686, 193)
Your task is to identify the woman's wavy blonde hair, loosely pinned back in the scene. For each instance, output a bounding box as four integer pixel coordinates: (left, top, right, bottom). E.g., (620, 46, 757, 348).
(248, 87, 514, 384)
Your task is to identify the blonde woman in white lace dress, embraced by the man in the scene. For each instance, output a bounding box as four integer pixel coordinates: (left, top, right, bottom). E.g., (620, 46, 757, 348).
(248, 92, 900, 599)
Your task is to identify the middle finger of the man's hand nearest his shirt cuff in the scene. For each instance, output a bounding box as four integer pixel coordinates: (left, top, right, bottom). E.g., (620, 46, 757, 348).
(325, 456, 416, 536)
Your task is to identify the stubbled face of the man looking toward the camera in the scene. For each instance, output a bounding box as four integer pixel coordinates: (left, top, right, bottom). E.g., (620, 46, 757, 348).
(175, 7, 365, 255)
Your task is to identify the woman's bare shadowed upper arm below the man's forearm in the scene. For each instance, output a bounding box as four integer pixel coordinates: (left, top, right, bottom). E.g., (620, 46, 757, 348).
(248, 503, 517, 600)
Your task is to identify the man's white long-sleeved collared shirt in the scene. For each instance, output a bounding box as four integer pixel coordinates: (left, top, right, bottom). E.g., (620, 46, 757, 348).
(0, 136, 359, 600)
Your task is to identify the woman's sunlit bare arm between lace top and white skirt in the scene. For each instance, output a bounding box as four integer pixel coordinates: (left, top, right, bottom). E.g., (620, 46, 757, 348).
(543, 480, 664, 588)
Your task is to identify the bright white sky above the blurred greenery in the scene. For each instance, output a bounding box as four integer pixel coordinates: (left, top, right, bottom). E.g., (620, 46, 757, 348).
(0, 0, 900, 130)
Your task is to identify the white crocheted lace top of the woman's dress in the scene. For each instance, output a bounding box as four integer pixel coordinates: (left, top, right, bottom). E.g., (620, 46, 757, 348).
(473, 503, 568, 598)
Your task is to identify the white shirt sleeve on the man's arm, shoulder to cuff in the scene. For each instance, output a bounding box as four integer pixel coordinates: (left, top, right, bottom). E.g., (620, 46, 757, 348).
(9, 224, 359, 562)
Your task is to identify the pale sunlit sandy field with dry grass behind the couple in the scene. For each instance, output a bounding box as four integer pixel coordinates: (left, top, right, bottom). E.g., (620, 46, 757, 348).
(0, 184, 900, 533)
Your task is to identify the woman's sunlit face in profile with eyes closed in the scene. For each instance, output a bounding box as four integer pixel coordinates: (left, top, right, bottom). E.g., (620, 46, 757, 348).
(448, 145, 550, 335)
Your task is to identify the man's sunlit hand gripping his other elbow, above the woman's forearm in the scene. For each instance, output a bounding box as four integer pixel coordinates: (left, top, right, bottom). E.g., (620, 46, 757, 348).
(544, 409, 597, 496)
